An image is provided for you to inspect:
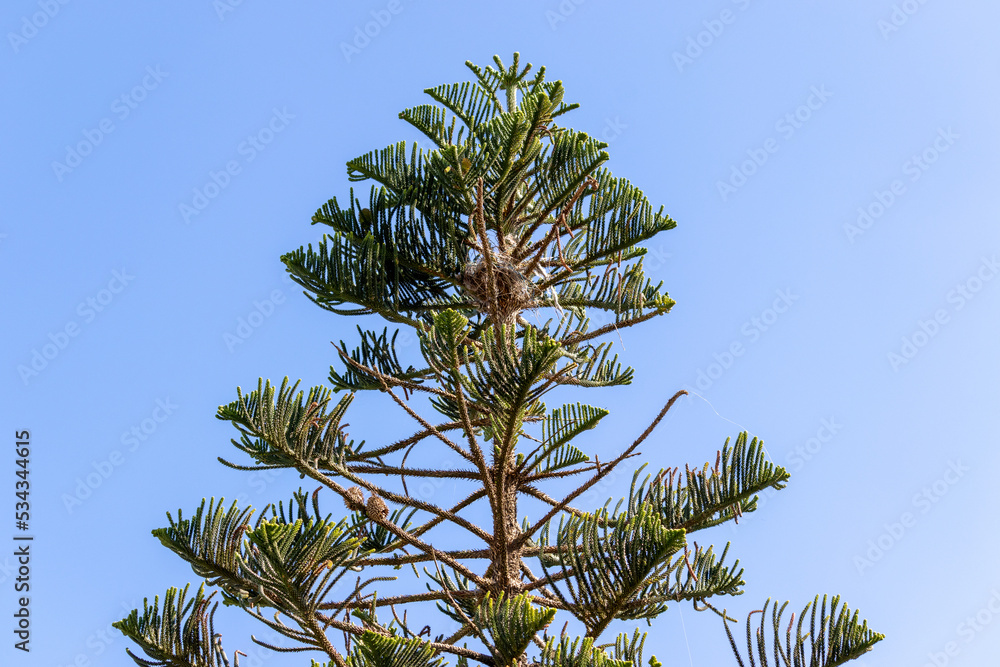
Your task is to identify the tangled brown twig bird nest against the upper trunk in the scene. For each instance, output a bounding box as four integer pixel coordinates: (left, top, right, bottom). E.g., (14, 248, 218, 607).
(462, 252, 538, 324)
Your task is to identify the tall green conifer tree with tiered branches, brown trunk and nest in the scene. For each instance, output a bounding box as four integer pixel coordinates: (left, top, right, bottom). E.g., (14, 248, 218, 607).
(115, 54, 882, 667)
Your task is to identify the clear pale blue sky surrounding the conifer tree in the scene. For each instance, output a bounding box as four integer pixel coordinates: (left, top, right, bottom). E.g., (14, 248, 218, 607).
(0, 0, 1000, 667)
